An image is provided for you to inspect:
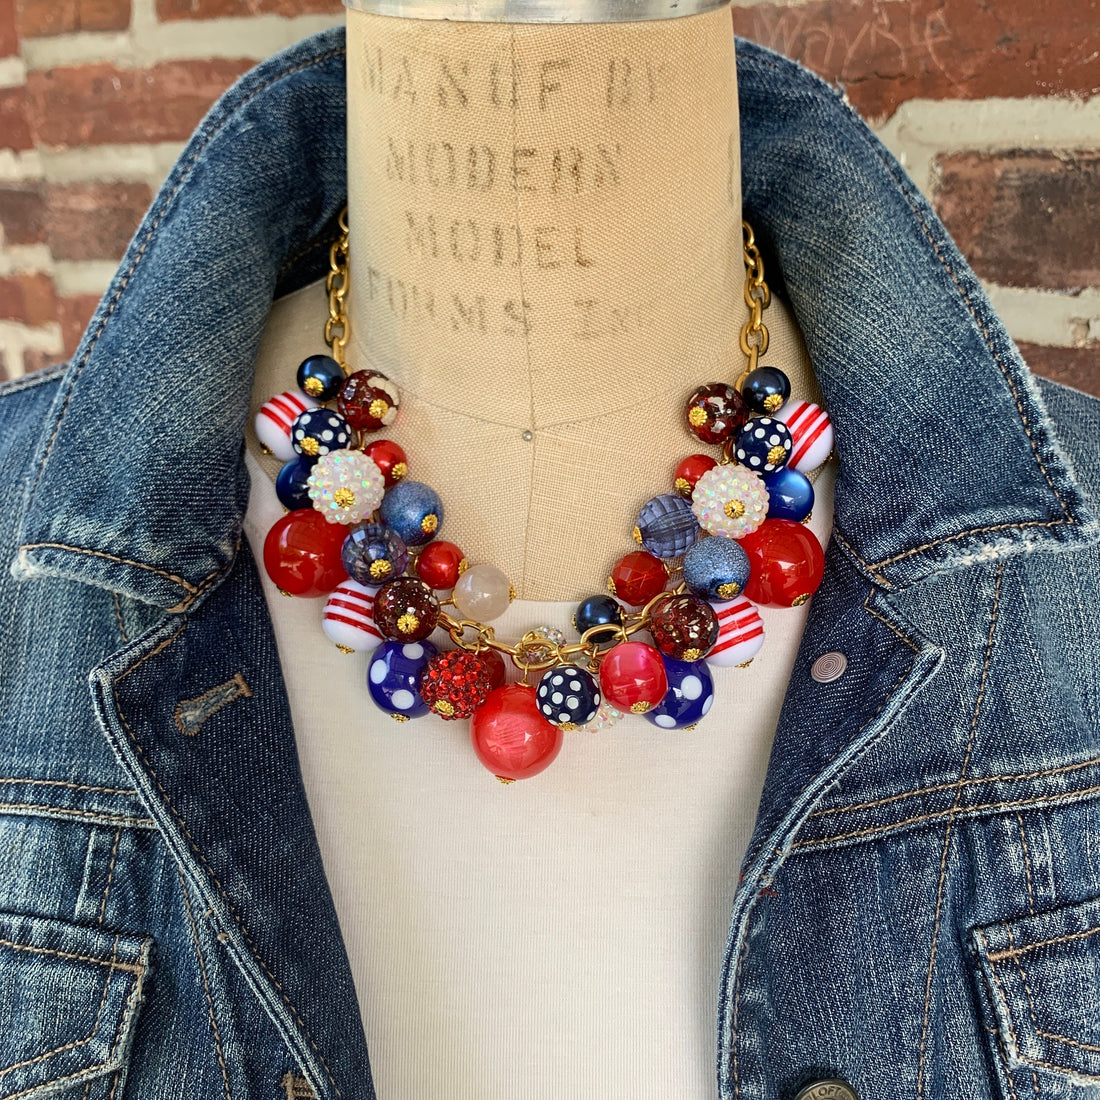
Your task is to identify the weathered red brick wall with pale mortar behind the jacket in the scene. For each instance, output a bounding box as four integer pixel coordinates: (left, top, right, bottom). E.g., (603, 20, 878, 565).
(0, 0, 1100, 395)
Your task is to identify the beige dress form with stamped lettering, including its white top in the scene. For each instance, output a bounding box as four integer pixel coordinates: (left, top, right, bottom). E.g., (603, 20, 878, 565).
(246, 6, 834, 1100)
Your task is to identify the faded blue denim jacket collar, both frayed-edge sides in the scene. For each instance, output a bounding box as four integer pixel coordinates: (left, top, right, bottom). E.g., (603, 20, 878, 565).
(14, 30, 1100, 612)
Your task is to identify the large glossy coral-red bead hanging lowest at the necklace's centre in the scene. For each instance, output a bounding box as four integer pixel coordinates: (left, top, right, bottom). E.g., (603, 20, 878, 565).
(470, 684, 564, 779)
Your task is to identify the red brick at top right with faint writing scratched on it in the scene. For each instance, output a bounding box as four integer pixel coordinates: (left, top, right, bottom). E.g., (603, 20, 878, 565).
(733, 0, 1100, 119)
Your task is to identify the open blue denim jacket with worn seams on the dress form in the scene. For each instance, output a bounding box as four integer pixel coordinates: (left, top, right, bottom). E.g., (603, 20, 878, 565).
(0, 23, 1100, 1100)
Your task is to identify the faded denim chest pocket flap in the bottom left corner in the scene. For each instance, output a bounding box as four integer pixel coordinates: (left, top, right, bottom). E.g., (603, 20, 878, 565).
(0, 913, 153, 1100)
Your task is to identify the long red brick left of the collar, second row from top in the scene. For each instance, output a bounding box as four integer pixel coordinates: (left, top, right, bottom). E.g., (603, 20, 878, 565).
(26, 58, 253, 146)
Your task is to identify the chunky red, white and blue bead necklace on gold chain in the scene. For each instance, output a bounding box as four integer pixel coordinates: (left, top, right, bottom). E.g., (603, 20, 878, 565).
(255, 209, 834, 782)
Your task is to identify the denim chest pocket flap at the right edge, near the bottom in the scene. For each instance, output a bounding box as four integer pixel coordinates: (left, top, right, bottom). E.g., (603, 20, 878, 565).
(971, 898, 1100, 1084)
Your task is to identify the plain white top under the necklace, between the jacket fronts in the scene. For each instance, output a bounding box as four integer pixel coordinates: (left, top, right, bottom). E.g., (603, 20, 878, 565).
(245, 454, 835, 1100)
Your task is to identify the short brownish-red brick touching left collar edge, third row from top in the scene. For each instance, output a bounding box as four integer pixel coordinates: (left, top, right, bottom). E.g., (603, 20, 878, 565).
(45, 183, 153, 260)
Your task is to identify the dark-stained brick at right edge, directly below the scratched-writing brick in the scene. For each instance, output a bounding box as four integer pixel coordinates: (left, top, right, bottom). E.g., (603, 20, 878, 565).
(935, 152, 1100, 289)
